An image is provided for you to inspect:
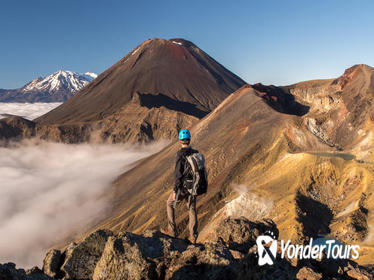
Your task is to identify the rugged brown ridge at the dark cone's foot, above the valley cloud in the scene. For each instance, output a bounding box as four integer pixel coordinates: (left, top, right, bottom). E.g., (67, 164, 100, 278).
(0, 94, 199, 143)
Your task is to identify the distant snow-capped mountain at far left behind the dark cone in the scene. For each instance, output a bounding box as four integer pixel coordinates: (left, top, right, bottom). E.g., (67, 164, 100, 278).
(0, 70, 97, 102)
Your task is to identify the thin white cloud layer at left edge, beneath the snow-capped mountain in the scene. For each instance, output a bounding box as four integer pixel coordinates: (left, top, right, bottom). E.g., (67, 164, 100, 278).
(0, 102, 62, 120)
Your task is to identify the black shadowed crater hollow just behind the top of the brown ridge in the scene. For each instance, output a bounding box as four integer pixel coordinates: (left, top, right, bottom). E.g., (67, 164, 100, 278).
(252, 83, 310, 116)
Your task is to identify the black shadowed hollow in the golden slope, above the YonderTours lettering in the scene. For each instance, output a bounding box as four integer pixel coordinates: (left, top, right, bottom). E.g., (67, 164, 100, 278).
(296, 192, 333, 238)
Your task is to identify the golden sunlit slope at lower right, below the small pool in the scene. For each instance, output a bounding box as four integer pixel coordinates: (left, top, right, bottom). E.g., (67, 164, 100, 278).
(216, 149, 374, 263)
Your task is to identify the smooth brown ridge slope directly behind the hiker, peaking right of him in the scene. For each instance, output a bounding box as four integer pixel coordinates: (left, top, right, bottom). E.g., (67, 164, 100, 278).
(84, 87, 329, 240)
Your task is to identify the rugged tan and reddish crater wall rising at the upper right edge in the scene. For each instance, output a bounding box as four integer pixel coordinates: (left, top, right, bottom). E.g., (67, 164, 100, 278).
(254, 64, 374, 153)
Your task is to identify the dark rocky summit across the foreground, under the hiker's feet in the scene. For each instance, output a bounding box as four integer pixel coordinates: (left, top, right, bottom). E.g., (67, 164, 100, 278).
(0, 217, 373, 280)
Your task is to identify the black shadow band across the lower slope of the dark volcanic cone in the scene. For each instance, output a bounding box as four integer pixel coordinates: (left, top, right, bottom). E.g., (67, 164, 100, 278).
(138, 93, 209, 119)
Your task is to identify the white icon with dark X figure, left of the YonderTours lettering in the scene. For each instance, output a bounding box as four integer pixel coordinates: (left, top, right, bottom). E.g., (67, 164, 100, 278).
(256, 233, 277, 266)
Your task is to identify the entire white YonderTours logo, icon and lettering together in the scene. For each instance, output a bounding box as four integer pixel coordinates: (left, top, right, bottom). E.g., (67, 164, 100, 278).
(256, 232, 360, 266)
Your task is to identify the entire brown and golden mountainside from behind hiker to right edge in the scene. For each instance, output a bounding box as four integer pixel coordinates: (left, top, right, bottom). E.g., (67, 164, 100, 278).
(65, 65, 374, 264)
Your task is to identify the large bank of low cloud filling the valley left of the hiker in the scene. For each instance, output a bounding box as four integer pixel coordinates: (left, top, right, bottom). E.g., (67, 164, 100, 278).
(0, 140, 166, 268)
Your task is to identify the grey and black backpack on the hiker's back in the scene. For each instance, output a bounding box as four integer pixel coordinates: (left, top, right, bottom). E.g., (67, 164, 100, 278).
(183, 153, 208, 196)
